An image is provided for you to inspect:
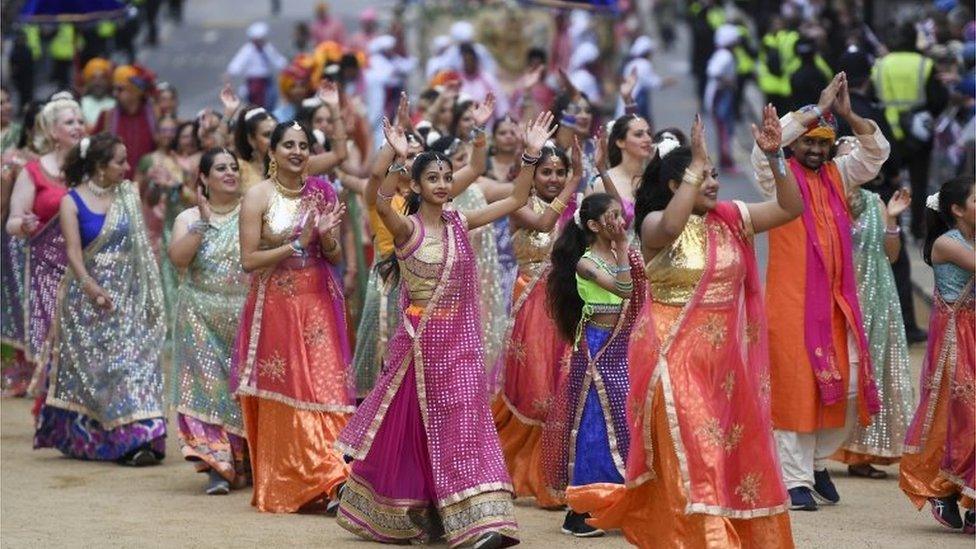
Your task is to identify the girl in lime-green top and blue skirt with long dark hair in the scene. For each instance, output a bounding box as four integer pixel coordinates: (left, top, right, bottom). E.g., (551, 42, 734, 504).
(542, 186, 644, 537)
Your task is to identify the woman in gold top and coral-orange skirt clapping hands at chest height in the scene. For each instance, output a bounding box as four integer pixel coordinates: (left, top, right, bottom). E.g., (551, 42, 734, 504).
(231, 122, 355, 513)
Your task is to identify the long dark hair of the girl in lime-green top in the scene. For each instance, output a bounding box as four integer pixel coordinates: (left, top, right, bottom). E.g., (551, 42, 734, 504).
(546, 193, 615, 341)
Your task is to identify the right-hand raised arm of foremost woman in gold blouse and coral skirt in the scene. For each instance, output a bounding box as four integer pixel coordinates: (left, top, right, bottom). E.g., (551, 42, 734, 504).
(743, 104, 803, 234)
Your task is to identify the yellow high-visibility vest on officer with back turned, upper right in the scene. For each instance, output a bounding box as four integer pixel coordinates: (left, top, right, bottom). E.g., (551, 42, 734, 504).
(871, 51, 934, 140)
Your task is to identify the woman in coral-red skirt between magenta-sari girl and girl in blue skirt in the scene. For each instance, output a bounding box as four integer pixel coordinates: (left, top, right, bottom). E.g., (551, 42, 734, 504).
(492, 139, 583, 508)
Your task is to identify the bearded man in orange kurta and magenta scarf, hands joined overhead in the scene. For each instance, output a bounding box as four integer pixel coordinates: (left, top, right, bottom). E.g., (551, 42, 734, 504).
(752, 73, 890, 511)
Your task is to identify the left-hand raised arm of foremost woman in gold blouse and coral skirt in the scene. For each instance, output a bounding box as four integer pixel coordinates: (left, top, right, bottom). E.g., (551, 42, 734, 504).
(640, 114, 708, 254)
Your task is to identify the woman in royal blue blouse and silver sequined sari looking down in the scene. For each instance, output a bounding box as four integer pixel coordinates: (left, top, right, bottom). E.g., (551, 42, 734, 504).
(34, 132, 166, 466)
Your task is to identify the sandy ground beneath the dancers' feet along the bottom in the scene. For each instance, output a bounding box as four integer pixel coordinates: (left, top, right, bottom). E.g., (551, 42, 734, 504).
(0, 332, 973, 549)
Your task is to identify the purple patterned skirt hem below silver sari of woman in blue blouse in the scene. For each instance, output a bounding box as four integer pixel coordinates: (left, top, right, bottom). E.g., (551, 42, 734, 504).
(34, 405, 166, 461)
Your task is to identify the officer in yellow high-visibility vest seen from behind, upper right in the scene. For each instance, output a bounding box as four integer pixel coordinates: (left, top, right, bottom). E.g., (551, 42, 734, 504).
(871, 23, 949, 239)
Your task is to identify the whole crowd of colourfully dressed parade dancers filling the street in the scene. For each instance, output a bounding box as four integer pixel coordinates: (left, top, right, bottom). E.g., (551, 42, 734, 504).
(0, 0, 976, 549)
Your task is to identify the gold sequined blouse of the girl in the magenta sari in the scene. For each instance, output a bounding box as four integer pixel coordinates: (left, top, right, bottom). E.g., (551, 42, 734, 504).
(396, 218, 445, 303)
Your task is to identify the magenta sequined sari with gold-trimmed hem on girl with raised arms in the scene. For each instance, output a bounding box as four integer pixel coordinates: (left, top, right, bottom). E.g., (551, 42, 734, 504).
(337, 211, 517, 547)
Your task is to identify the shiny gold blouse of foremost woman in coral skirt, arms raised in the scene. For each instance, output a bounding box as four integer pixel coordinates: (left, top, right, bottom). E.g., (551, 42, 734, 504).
(645, 215, 746, 306)
